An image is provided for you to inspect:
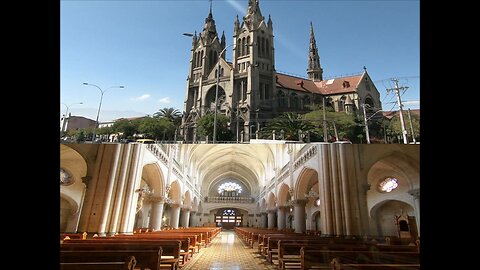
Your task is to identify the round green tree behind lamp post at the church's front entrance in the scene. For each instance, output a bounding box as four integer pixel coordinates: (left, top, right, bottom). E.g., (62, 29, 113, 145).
(197, 113, 233, 141)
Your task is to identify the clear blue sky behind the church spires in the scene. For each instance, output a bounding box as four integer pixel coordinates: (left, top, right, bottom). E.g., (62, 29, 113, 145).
(59, 0, 420, 122)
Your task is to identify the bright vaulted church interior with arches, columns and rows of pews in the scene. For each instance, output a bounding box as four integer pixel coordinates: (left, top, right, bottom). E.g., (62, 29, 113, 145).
(60, 143, 420, 269)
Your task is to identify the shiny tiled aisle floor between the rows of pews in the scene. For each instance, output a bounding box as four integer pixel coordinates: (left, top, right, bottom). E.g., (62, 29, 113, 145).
(182, 231, 276, 270)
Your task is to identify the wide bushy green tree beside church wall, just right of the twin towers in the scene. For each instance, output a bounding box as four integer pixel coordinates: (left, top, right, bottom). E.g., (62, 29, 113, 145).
(260, 112, 315, 141)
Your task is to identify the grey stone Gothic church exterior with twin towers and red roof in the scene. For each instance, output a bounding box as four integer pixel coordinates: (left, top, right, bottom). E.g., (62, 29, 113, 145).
(181, 0, 382, 141)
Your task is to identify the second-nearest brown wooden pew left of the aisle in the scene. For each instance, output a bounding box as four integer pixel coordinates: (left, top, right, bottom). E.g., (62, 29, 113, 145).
(60, 237, 181, 270)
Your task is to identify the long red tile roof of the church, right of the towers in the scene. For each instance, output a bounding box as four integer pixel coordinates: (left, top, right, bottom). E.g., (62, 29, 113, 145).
(277, 73, 363, 95)
